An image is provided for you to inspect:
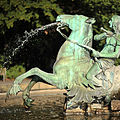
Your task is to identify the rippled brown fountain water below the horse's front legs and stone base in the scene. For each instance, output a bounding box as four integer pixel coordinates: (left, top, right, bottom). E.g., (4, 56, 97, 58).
(0, 95, 120, 120)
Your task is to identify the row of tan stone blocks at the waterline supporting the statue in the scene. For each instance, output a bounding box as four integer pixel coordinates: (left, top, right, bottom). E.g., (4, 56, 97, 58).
(64, 100, 120, 116)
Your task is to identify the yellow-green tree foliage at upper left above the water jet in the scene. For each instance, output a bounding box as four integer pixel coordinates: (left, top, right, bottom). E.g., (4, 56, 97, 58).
(0, 0, 63, 33)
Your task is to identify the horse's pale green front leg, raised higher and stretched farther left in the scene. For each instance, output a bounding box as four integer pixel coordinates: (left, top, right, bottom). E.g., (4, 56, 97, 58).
(7, 68, 60, 97)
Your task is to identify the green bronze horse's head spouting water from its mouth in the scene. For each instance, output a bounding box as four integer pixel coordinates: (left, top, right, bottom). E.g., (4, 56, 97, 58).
(56, 15, 95, 31)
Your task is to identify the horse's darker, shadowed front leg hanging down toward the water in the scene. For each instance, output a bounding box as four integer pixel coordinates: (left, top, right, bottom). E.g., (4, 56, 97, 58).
(22, 76, 40, 108)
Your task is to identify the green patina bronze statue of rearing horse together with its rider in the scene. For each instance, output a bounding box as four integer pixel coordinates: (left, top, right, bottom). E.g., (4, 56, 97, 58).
(7, 15, 120, 109)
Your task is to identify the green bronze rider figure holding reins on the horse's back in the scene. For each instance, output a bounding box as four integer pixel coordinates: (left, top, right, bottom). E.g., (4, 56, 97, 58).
(86, 15, 120, 86)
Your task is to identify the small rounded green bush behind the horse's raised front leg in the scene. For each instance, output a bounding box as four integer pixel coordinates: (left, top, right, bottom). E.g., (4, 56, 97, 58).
(6, 65, 25, 79)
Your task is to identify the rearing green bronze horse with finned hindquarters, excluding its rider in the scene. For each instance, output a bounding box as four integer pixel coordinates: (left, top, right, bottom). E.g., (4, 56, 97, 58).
(7, 15, 120, 109)
